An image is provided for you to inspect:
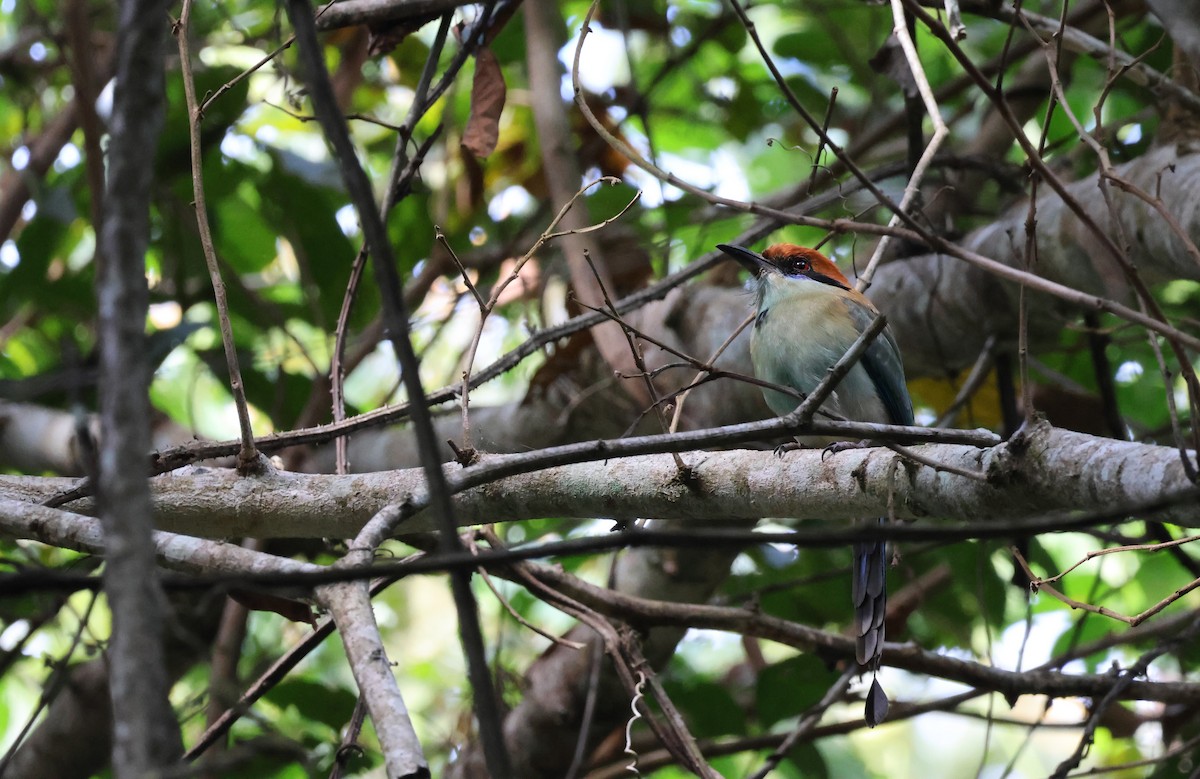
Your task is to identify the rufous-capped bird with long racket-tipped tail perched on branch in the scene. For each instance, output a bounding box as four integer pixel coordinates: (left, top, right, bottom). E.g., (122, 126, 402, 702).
(718, 244, 913, 727)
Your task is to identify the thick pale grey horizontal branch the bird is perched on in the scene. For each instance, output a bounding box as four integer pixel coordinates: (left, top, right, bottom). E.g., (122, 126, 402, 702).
(0, 425, 1195, 538)
